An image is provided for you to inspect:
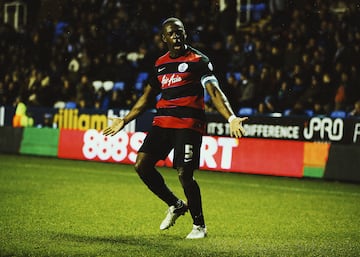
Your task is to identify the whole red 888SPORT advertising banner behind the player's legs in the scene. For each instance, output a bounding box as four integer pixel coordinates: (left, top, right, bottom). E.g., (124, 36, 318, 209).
(58, 129, 304, 177)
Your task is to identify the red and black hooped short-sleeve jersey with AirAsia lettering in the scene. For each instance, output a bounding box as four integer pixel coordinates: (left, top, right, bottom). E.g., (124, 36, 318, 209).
(149, 46, 213, 133)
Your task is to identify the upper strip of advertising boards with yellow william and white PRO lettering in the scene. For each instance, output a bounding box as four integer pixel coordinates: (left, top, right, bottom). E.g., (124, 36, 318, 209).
(0, 107, 360, 144)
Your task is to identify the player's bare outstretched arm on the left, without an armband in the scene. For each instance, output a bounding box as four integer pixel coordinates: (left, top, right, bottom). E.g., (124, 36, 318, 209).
(103, 85, 157, 136)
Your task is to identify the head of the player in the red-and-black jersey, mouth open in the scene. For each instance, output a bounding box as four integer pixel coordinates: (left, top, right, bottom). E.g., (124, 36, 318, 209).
(163, 21, 186, 57)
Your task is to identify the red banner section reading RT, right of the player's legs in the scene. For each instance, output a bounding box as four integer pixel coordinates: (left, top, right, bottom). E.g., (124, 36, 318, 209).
(195, 137, 304, 177)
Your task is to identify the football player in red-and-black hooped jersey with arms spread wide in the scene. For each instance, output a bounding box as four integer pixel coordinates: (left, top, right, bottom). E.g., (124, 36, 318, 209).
(103, 18, 247, 239)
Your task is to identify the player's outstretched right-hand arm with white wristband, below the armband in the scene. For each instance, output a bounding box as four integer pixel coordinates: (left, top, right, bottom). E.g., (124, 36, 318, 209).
(205, 78, 248, 138)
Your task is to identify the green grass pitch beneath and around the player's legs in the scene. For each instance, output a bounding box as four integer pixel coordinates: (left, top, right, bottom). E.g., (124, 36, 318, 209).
(0, 155, 360, 257)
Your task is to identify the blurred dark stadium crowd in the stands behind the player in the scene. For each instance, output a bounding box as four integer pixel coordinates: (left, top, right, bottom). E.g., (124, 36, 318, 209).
(0, 0, 360, 115)
